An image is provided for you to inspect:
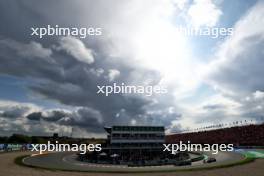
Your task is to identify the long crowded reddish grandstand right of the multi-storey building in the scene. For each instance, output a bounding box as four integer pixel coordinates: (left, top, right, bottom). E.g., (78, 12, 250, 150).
(165, 123, 264, 146)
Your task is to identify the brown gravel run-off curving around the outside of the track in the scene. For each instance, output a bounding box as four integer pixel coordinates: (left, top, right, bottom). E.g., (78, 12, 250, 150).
(0, 152, 264, 176)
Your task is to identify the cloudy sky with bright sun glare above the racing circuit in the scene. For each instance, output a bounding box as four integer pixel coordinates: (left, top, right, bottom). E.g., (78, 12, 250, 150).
(0, 0, 264, 137)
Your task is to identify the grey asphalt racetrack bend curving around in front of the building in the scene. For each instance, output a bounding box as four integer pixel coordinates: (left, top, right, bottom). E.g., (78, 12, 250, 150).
(23, 152, 244, 173)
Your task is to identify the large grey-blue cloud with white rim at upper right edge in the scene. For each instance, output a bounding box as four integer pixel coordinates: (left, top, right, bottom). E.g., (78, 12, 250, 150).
(210, 3, 264, 94)
